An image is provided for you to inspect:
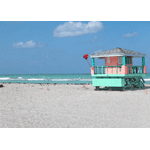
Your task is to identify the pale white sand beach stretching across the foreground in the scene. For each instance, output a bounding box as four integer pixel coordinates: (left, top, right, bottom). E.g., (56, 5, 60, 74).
(0, 84, 150, 128)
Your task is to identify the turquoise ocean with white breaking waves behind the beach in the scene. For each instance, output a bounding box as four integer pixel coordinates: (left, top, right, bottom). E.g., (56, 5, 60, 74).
(0, 73, 150, 84)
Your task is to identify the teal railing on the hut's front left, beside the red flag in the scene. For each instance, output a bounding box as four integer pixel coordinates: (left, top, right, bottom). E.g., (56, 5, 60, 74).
(94, 65, 122, 74)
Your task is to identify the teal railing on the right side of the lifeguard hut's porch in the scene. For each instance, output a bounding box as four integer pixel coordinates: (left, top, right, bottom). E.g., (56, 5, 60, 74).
(127, 66, 144, 74)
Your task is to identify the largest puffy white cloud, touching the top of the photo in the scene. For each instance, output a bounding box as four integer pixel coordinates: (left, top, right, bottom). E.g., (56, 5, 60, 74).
(53, 21, 103, 37)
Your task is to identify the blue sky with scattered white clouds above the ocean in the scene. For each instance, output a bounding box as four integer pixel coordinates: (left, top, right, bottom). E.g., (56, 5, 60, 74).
(0, 21, 150, 74)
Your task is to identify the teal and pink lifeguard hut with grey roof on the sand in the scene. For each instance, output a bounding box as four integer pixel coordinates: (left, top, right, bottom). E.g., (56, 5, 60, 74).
(90, 48, 146, 90)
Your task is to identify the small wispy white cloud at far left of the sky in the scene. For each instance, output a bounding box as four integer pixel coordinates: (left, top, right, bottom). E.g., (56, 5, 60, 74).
(12, 40, 45, 49)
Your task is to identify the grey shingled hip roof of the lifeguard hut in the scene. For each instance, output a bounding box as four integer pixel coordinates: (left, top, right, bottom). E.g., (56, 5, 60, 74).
(90, 48, 146, 58)
